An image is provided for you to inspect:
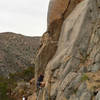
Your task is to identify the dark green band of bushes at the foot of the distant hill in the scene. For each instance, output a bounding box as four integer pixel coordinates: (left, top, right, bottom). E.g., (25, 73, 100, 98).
(0, 67, 34, 100)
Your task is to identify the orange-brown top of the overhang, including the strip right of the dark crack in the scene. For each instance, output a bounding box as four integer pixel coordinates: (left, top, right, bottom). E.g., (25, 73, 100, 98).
(48, 0, 82, 25)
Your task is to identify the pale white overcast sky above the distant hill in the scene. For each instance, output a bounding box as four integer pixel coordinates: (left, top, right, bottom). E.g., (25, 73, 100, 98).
(0, 0, 49, 36)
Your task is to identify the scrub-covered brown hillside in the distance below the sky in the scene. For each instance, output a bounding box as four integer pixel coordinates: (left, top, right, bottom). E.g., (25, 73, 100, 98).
(0, 32, 40, 76)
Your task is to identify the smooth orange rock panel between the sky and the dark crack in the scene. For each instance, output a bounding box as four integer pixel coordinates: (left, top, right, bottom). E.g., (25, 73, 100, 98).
(48, 0, 69, 24)
